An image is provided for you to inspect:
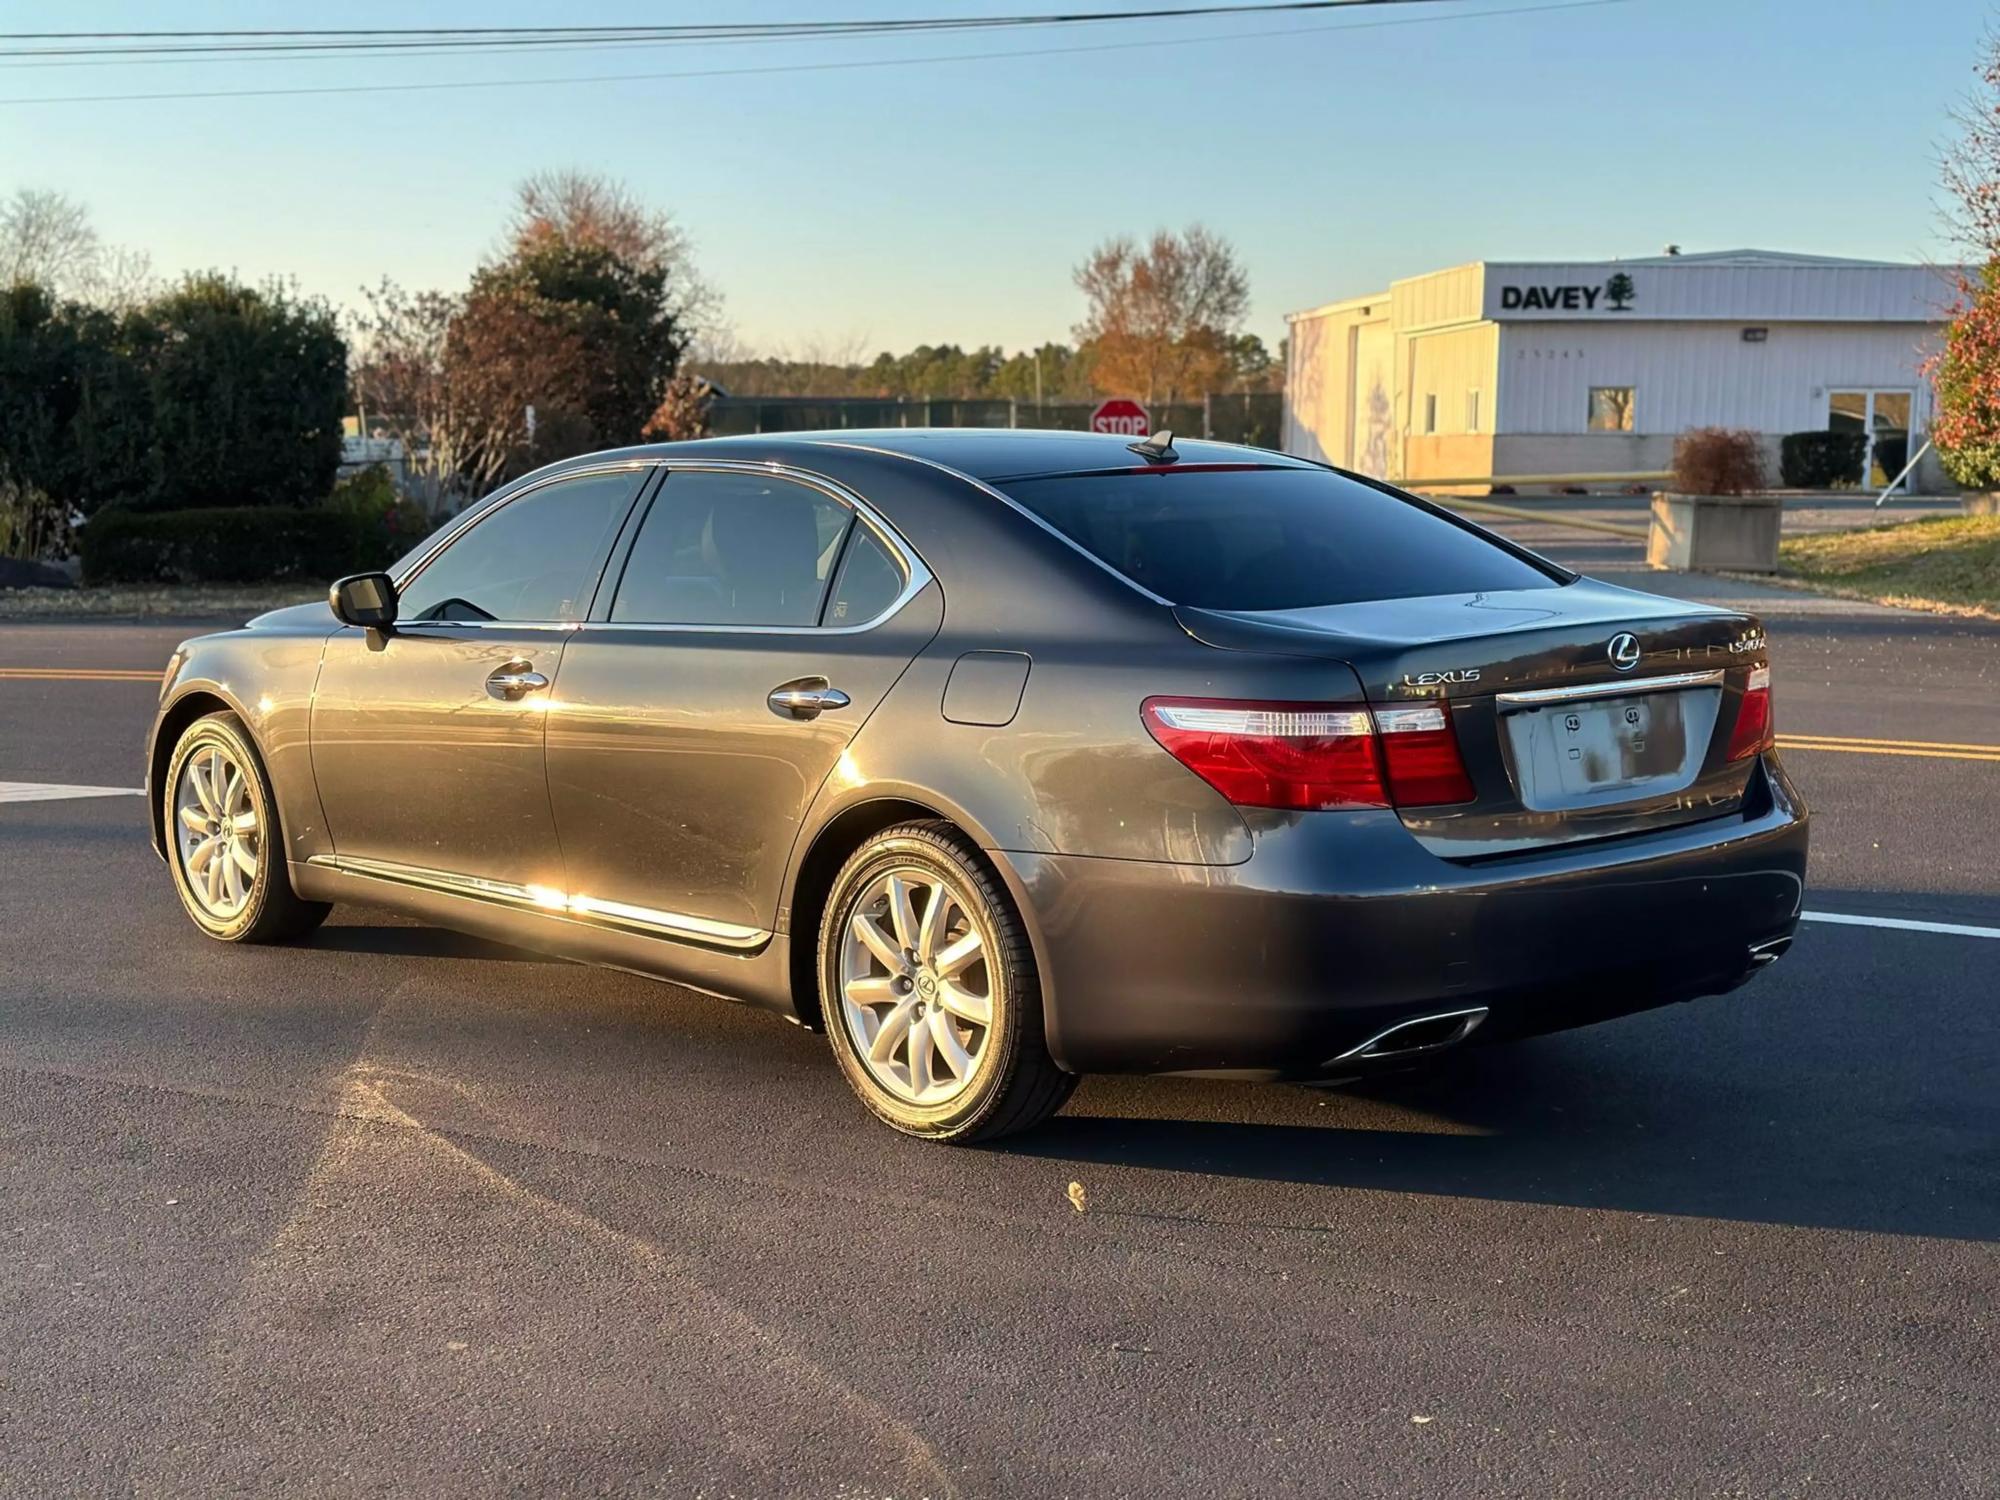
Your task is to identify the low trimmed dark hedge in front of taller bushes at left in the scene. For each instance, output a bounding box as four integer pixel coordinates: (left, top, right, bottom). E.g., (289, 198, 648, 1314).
(82, 506, 416, 584)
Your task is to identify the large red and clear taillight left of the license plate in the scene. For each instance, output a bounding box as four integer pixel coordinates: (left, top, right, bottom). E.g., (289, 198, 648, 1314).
(1144, 698, 1474, 810)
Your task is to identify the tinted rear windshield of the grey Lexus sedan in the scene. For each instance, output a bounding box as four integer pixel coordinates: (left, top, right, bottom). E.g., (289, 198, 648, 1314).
(1000, 468, 1560, 610)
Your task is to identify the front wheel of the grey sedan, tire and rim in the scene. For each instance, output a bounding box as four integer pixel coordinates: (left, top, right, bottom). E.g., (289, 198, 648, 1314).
(160, 712, 332, 942)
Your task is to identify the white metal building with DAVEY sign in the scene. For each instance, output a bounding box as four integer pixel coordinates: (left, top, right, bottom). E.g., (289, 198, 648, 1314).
(1284, 250, 1956, 488)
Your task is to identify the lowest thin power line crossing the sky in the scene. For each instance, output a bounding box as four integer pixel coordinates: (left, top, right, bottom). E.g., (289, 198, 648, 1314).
(0, 0, 1632, 106)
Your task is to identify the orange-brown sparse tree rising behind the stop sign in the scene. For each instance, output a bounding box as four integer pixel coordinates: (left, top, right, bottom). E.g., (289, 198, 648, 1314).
(1076, 224, 1250, 402)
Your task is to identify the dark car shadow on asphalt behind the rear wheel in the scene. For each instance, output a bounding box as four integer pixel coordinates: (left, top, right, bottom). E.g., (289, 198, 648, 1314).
(1000, 1012, 2000, 1240)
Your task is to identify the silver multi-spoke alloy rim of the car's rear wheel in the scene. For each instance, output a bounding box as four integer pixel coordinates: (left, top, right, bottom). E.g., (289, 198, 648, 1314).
(840, 866, 994, 1106)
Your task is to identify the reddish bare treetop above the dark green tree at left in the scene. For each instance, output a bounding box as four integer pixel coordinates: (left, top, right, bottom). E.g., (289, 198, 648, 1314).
(502, 168, 722, 330)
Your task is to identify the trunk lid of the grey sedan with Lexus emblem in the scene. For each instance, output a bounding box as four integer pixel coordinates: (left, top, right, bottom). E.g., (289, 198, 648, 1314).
(1176, 580, 1766, 860)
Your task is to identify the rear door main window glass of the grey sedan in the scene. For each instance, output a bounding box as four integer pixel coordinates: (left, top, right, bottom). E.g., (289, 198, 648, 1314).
(612, 470, 854, 626)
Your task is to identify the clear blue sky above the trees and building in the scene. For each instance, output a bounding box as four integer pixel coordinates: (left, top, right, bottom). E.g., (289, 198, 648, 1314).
(0, 0, 1992, 352)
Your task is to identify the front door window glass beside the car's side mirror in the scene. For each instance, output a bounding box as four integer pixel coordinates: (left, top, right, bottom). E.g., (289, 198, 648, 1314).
(398, 470, 640, 624)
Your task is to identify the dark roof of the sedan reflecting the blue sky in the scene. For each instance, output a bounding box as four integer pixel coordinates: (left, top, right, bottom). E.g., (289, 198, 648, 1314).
(580, 428, 1316, 482)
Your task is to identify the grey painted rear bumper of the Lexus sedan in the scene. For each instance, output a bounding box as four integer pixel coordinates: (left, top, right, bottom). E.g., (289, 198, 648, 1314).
(996, 756, 1806, 1078)
